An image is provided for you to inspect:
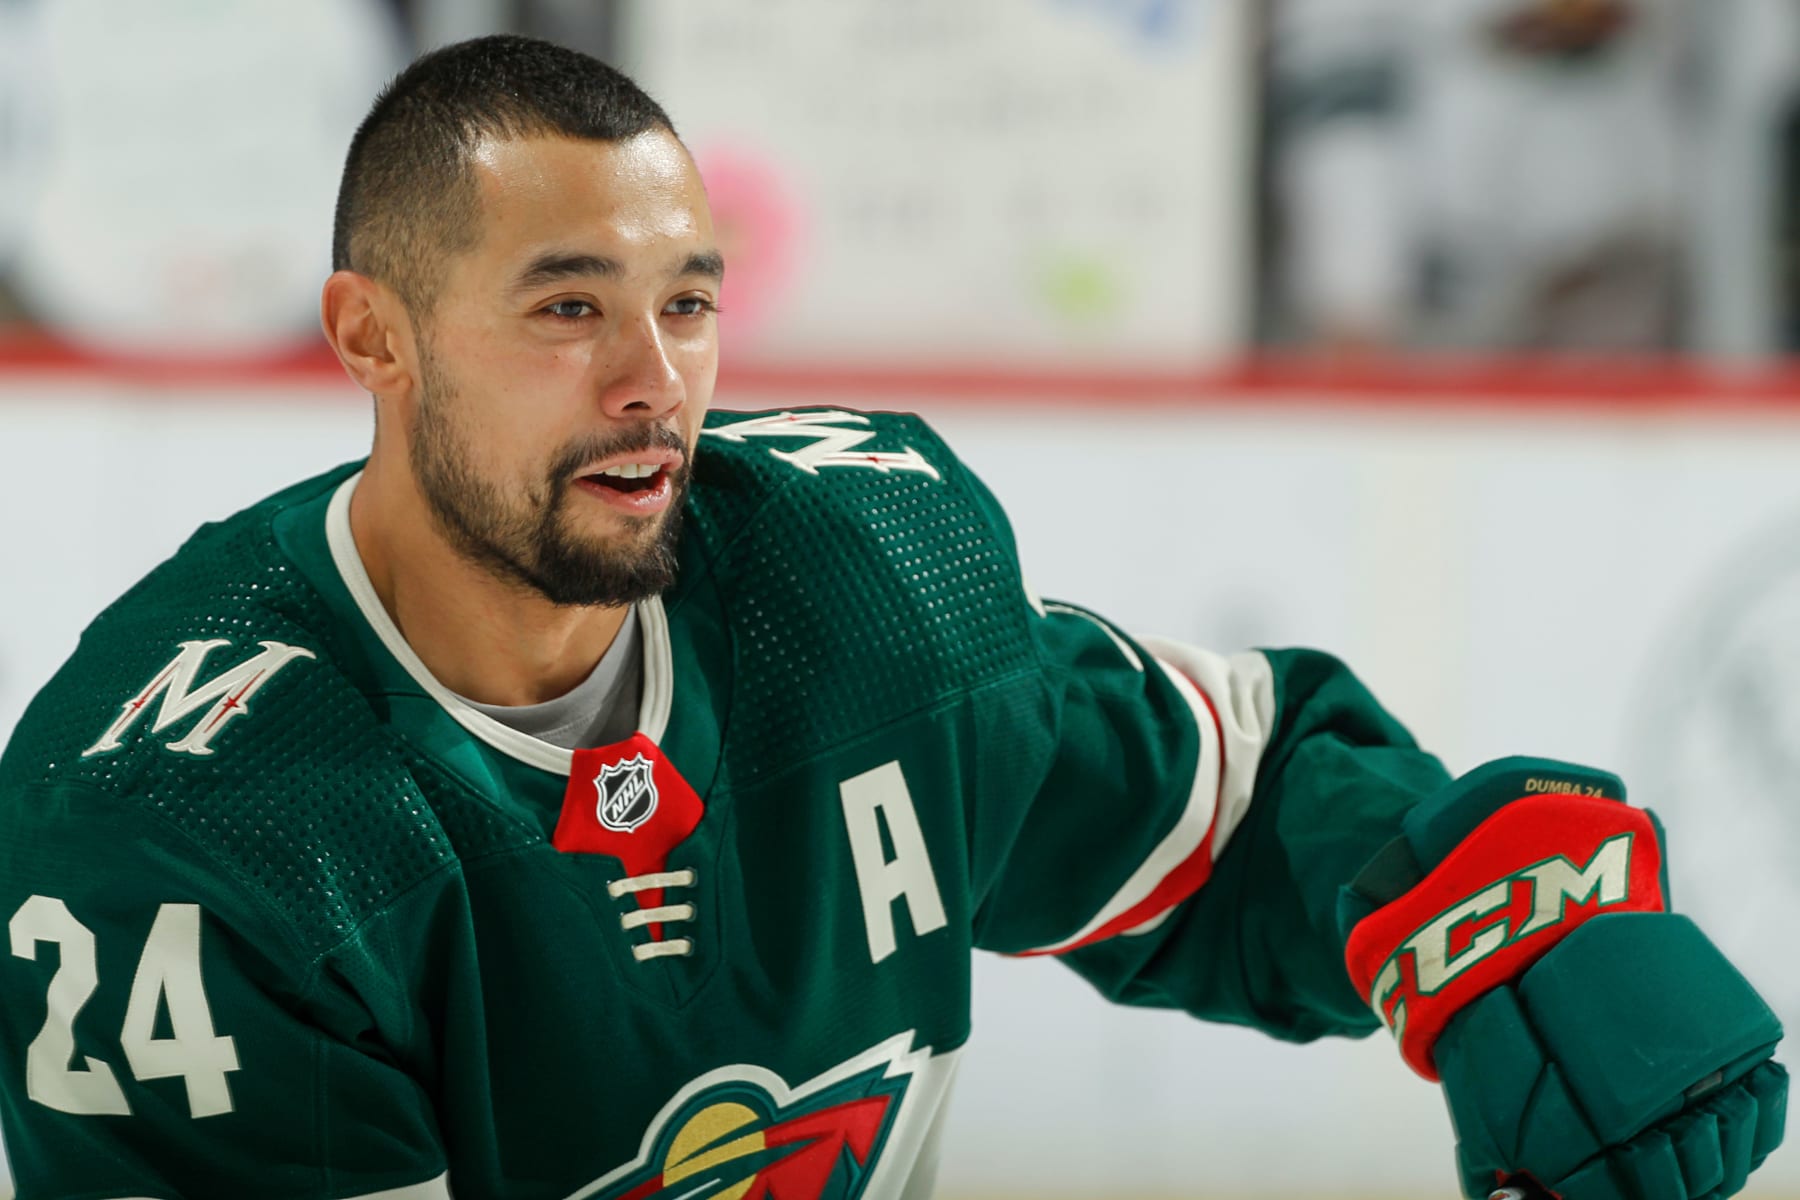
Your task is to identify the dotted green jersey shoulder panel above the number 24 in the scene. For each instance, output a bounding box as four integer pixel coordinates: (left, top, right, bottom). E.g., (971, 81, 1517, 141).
(0, 473, 450, 948)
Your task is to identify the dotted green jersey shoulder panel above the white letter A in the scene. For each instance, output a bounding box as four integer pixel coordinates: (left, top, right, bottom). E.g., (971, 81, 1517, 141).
(689, 408, 1035, 723)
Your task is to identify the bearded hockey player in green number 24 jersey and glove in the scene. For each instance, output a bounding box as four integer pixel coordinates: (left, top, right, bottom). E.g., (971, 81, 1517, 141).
(0, 38, 1786, 1200)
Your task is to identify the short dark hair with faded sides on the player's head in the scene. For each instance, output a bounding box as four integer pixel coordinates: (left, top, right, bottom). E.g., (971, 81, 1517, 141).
(331, 34, 675, 315)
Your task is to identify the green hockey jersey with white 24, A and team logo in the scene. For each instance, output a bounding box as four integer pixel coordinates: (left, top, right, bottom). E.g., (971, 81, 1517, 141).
(0, 410, 1445, 1200)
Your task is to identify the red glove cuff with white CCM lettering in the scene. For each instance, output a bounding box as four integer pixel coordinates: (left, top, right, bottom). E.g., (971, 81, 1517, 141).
(1345, 795, 1667, 1081)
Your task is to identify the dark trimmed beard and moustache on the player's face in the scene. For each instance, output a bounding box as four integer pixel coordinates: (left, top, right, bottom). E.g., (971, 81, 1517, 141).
(409, 354, 693, 608)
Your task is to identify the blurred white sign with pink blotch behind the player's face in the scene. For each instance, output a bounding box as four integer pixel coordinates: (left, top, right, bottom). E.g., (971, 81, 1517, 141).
(621, 0, 1256, 367)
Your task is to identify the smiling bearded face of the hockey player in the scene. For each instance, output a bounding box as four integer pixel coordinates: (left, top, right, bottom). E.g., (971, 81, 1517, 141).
(407, 133, 722, 604)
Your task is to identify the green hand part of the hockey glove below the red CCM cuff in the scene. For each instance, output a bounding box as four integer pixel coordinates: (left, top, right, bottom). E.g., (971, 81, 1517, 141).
(1436, 912, 1787, 1200)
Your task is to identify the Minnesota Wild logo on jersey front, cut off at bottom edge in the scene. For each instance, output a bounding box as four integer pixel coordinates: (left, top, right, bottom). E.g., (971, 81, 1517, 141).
(571, 1034, 931, 1200)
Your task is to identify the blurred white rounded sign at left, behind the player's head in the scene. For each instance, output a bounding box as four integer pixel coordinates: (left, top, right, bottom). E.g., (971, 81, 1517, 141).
(0, 0, 405, 356)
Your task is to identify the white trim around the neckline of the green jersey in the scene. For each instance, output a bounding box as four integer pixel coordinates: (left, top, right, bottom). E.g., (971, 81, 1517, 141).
(326, 471, 675, 775)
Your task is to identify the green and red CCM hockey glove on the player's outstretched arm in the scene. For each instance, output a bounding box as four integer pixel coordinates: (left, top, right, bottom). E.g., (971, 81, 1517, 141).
(1339, 759, 1787, 1200)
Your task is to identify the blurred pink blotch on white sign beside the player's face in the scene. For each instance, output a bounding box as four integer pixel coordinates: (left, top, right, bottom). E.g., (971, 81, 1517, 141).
(695, 146, 805, 340)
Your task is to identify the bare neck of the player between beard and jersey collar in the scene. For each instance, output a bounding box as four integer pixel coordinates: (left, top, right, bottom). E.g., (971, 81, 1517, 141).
(349, 457, 628, 705)
